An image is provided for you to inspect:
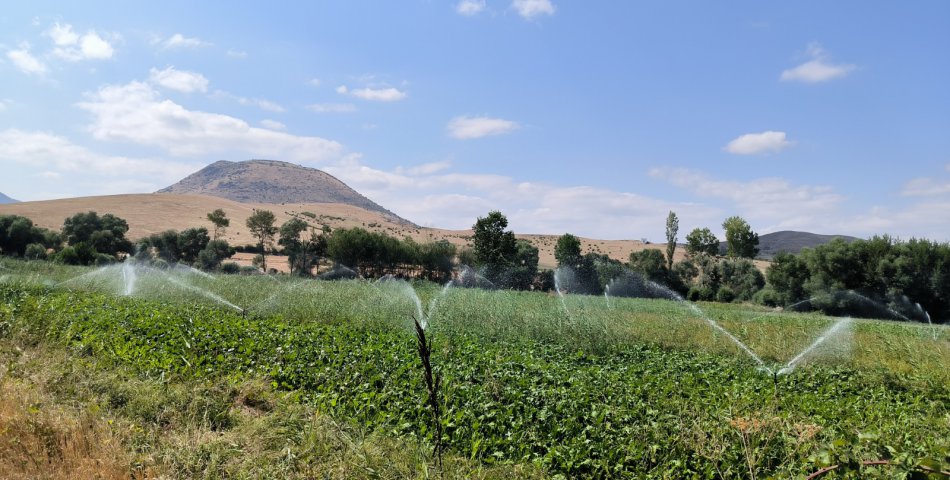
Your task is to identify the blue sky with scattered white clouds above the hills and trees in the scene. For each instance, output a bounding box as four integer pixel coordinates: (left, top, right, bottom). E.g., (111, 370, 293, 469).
(0, 0, 950, 241)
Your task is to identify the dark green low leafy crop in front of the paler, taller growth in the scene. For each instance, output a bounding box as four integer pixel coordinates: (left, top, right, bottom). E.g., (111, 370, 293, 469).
(0, 279, 950, 478)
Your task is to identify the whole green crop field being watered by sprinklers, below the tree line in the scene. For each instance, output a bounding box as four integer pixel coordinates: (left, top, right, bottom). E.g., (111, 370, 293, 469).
(0, 261, 950, 478)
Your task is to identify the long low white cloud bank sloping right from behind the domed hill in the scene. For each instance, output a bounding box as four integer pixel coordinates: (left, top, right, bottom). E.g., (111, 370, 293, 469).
(324, 156, 722, 238)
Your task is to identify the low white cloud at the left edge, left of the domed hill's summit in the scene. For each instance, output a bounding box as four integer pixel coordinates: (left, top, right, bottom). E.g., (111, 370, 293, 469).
(0, 129, 194, 180)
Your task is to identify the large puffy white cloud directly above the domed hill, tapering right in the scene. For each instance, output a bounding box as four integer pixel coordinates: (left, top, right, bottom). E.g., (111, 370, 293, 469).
(77, 82, 343, 164)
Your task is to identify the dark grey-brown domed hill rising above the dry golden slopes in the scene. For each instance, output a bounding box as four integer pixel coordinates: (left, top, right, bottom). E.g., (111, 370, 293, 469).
(157, 160, 415, 226)
